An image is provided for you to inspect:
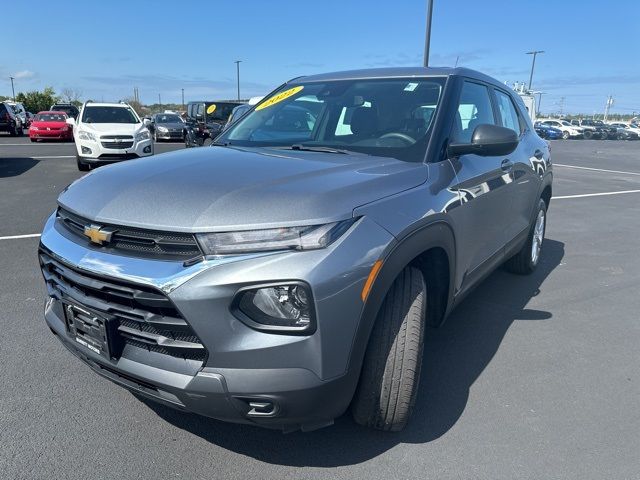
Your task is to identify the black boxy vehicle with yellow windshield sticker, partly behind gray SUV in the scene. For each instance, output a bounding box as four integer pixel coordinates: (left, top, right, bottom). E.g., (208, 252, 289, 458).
(184, 100, 244, 147)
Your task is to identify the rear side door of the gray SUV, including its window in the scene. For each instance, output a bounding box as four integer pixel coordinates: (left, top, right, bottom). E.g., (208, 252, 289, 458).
(494, 88, 549, 243)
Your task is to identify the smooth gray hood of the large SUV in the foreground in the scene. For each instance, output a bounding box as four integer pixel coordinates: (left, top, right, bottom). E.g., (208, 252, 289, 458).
(58, 147, 427, 232)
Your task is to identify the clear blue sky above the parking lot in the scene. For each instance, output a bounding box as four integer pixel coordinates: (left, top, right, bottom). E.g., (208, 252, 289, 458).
(0, 0, 640, 114)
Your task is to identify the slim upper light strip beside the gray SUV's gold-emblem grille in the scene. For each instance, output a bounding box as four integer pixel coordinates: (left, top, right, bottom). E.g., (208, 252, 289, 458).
(196, 219, 356, 255)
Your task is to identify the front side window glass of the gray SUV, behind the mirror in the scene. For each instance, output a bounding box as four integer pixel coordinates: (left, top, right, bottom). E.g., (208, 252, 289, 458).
(451, 81, 496, 143)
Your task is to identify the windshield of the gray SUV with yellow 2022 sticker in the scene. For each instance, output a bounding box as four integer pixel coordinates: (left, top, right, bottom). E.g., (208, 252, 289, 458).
(217, 78, 444, 162)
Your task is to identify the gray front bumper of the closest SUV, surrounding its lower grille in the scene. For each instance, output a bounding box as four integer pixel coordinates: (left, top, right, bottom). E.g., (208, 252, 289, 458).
(41, 212, 393, 429)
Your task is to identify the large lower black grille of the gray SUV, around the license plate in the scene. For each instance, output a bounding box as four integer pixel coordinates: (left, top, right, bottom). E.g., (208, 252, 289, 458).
(39, 247, 207, 362)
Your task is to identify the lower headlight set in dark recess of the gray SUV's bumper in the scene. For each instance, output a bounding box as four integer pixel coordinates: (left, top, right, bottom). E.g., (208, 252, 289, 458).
(232, 282, 315, 335)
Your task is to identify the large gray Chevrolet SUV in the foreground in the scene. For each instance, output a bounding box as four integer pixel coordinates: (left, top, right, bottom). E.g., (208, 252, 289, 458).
(39, 68, 552, 431)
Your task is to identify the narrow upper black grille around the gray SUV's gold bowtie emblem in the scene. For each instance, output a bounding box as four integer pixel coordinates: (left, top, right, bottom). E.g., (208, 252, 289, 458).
(56, 208, 202, 261)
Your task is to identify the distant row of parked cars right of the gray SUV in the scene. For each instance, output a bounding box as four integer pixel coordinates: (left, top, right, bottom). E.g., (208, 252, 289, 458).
(535, 119, 640, 140)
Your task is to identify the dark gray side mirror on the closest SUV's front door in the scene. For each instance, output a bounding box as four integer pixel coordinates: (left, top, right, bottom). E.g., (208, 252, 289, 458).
(447, 123, 518, 157)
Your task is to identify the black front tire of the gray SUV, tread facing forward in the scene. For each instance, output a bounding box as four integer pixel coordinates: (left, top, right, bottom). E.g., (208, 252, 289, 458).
(351, 267, 427, 432)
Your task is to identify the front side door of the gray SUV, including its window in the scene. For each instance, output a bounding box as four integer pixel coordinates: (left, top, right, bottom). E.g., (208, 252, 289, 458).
(449, 80, 512, 289)
